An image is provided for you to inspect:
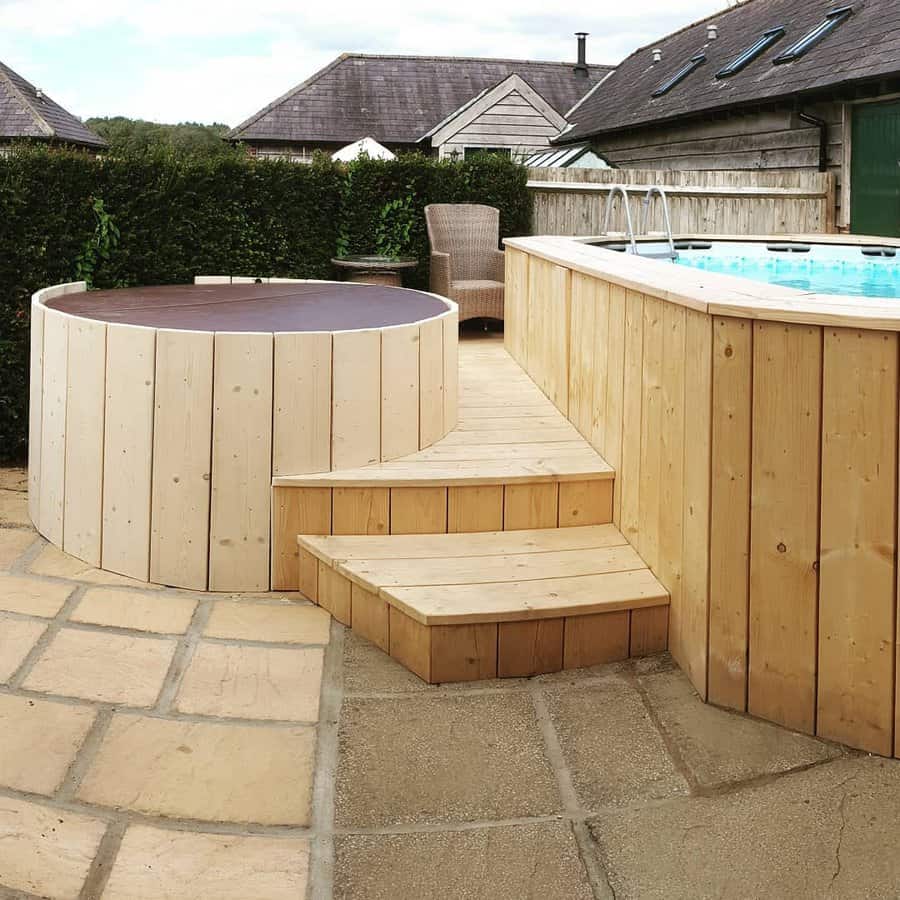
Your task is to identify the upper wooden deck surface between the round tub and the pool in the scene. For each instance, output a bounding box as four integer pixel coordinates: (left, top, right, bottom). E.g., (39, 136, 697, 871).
(272, 335, 614, 487)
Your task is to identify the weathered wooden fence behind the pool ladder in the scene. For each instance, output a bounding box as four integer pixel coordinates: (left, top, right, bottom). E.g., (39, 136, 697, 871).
(528, 169, 836, 236)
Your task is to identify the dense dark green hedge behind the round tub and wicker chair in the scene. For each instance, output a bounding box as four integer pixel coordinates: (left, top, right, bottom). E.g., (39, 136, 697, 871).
(0, 146, 531, 462)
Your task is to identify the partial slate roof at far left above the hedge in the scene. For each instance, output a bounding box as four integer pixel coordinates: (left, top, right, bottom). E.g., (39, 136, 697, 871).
(0, 62, 106, 147)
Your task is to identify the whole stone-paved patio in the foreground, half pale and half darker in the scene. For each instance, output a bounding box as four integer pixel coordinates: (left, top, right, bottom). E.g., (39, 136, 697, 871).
(0, 470, 900, 900)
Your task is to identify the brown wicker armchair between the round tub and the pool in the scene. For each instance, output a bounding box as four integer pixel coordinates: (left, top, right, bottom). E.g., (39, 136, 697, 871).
(425, 203, 504, 322)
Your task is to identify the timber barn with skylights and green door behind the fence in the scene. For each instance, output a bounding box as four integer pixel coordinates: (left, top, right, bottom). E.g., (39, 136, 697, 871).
(554, 0, 900, 235)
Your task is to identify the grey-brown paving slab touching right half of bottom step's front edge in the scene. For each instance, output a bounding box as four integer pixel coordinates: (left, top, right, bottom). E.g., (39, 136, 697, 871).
(547, 673, 688, 809)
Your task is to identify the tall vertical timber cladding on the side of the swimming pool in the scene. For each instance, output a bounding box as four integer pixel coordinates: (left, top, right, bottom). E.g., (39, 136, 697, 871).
(506, 248, 900, 755)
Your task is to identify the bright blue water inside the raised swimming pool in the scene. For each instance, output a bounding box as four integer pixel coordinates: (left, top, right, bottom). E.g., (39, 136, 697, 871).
(676, 241, 900, 299)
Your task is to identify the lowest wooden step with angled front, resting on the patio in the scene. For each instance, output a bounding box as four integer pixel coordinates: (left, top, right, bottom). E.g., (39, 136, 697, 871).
(298, 525, 669, 682)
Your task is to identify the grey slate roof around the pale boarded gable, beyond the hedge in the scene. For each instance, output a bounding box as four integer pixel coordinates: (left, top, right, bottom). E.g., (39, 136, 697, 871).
(227, 53, 612, 144)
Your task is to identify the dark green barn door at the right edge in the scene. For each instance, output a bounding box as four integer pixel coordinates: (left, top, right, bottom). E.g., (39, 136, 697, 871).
(850, 103, 900, 237)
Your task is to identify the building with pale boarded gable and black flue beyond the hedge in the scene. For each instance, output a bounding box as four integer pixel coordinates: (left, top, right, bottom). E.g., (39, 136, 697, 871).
(227, 35, 612, 160)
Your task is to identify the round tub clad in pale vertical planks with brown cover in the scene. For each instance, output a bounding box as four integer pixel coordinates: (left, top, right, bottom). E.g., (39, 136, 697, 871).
(29, 276, 458, 591)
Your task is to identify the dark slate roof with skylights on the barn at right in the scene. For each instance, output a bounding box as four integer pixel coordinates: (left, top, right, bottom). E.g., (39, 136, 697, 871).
(556, 0, 900, 142)
